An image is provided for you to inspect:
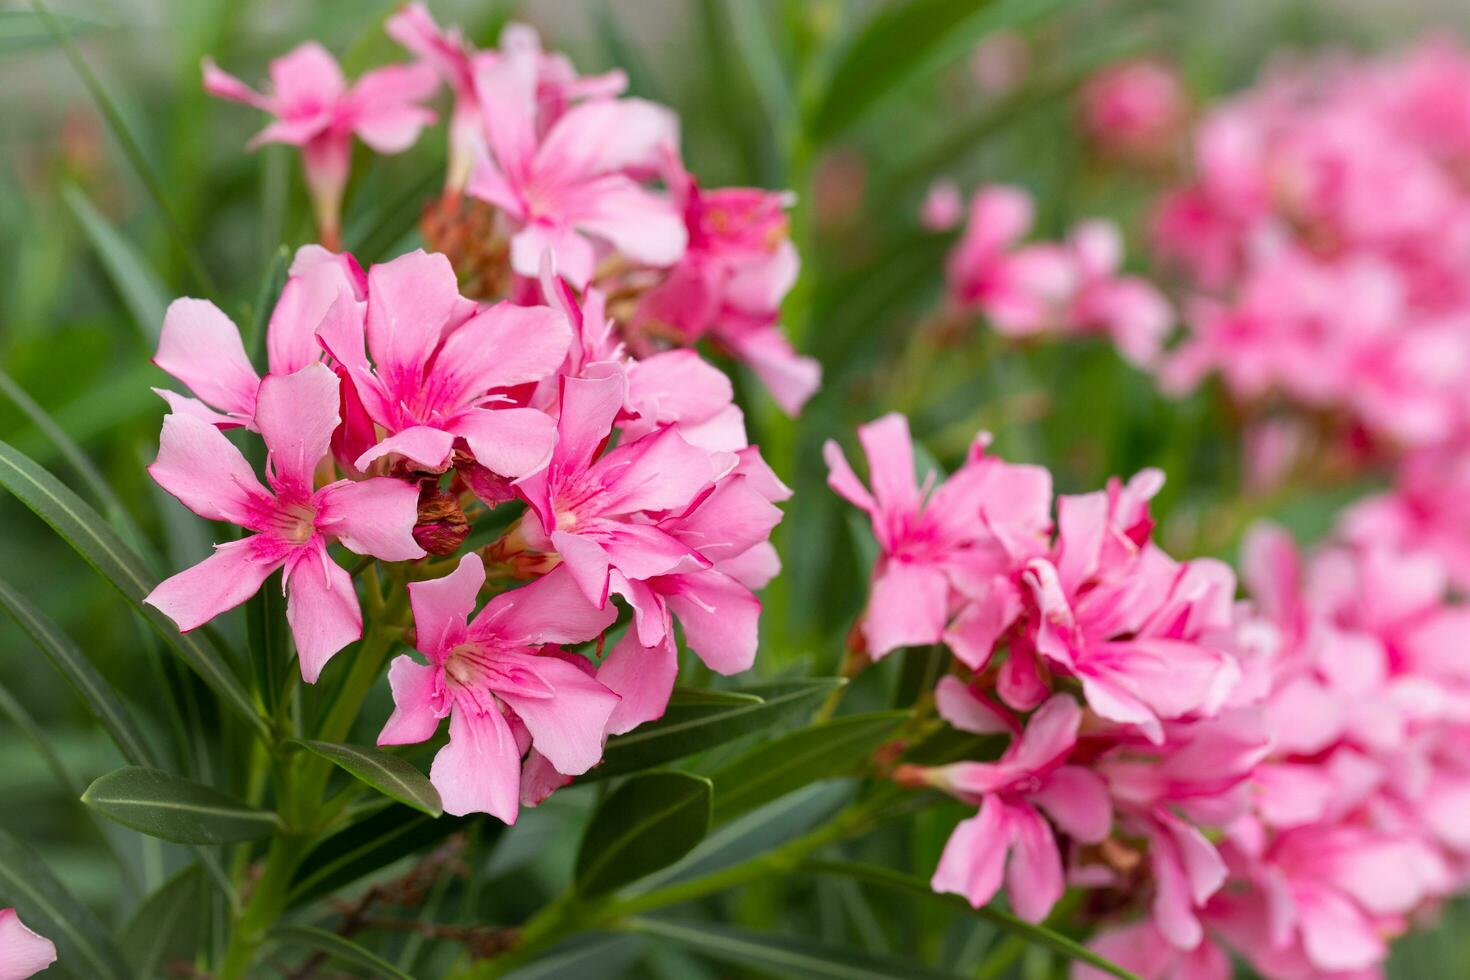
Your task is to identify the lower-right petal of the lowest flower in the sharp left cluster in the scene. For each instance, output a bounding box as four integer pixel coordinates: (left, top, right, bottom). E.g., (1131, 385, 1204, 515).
(495, 654, 617, 776)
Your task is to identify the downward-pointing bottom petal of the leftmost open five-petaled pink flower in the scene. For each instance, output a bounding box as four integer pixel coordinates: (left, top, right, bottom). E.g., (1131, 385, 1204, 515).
(285, 539, 363, 683)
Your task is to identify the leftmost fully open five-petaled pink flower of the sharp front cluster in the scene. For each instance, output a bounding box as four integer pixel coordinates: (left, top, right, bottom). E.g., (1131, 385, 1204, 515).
(144, 364, 425, 683)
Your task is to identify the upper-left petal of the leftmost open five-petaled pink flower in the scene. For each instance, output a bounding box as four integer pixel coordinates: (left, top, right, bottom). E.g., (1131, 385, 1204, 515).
(148, 414, 270, 527)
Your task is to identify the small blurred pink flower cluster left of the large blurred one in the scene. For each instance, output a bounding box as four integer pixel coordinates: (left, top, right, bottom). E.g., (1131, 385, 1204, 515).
(923, 185, 1173, 364)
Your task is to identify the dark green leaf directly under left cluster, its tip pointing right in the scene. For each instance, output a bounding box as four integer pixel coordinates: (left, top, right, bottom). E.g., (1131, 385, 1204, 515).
(579, 677, 847, 782)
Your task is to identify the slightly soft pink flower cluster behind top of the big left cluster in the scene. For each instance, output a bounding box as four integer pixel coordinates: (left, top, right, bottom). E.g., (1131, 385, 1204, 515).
(204, 3, 820, 414)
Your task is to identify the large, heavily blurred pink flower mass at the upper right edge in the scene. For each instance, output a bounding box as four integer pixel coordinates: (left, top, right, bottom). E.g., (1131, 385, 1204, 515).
(1154, 43, 1470, 451)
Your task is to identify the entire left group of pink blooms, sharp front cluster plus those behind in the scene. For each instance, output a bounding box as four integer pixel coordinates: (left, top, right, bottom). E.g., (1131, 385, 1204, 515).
(147, 15, 817, 823)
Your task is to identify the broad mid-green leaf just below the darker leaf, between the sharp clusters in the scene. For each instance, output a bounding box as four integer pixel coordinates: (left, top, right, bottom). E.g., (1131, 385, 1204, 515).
(710, 711, 908, 824)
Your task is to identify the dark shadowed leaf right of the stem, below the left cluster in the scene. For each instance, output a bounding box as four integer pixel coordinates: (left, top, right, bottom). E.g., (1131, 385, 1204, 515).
(295, 804, 479, 908)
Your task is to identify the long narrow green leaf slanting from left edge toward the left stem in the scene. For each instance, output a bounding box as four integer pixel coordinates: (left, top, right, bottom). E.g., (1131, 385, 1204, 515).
(0, 442, 270, 735)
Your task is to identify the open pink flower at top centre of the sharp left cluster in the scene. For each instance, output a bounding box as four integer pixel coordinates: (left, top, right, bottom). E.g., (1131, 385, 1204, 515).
(319, 251, 570, 478)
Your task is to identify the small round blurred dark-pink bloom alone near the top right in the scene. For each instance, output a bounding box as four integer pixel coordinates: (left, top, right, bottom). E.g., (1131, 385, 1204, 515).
(1082, 59, 1186, 160)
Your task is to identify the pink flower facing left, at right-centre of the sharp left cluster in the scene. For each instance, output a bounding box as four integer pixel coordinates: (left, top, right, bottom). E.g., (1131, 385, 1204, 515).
(516, 366, 734, 608)
